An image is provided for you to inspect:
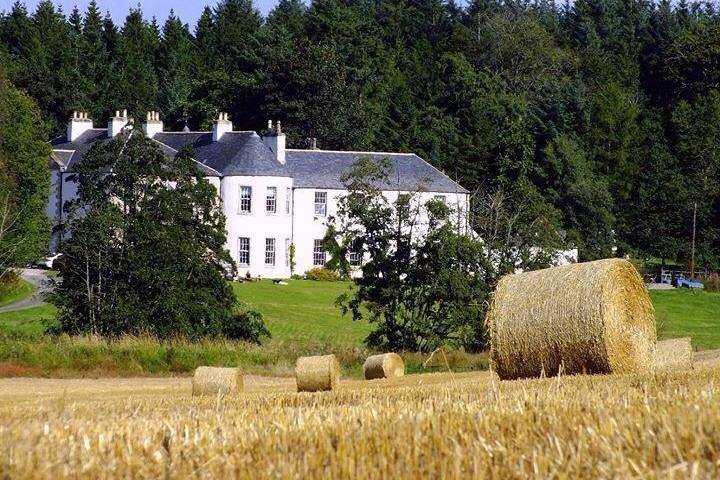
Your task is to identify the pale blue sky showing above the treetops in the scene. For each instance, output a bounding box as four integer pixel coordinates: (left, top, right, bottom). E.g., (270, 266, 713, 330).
(0, 0, 278, 26)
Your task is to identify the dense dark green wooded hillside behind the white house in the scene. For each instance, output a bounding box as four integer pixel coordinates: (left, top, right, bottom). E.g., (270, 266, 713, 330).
(0, 0, 720, 269)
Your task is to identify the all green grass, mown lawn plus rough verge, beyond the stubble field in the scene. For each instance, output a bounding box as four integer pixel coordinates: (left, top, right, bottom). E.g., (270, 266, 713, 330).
(0, 280, 720, 378)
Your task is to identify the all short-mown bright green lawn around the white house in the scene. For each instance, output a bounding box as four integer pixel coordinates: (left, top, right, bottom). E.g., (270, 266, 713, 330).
(0, 280, 720, 350)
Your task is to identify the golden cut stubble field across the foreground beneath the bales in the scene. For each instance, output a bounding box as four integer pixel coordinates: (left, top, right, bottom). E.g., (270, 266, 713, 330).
(0, 355, 720, 478)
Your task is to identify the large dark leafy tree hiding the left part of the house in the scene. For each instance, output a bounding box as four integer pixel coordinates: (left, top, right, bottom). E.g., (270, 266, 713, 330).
(51, 132, 269, 342)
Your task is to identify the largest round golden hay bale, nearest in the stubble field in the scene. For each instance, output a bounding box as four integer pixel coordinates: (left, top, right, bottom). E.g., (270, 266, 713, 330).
(486, 259, 656, 379)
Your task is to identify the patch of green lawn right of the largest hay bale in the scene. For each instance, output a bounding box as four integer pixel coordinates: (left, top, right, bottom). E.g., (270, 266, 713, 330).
(650, 289, 720, 350)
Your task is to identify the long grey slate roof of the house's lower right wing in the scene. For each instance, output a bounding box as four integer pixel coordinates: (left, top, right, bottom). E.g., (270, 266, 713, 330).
(286, 150, 468, 193)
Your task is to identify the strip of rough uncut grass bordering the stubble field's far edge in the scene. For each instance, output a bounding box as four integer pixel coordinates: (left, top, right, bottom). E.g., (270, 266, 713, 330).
(0, 336, 488, 378)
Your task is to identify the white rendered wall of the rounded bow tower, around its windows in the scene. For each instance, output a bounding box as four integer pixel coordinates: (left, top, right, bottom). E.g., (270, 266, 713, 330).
(220, 176, 292, 278)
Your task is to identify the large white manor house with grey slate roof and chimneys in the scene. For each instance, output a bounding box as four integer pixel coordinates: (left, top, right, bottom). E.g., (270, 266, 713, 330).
(48, 112, 469, 278)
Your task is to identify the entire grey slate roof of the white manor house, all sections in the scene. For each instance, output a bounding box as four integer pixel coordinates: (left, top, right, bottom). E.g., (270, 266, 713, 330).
(50, 128, 468, 193)
